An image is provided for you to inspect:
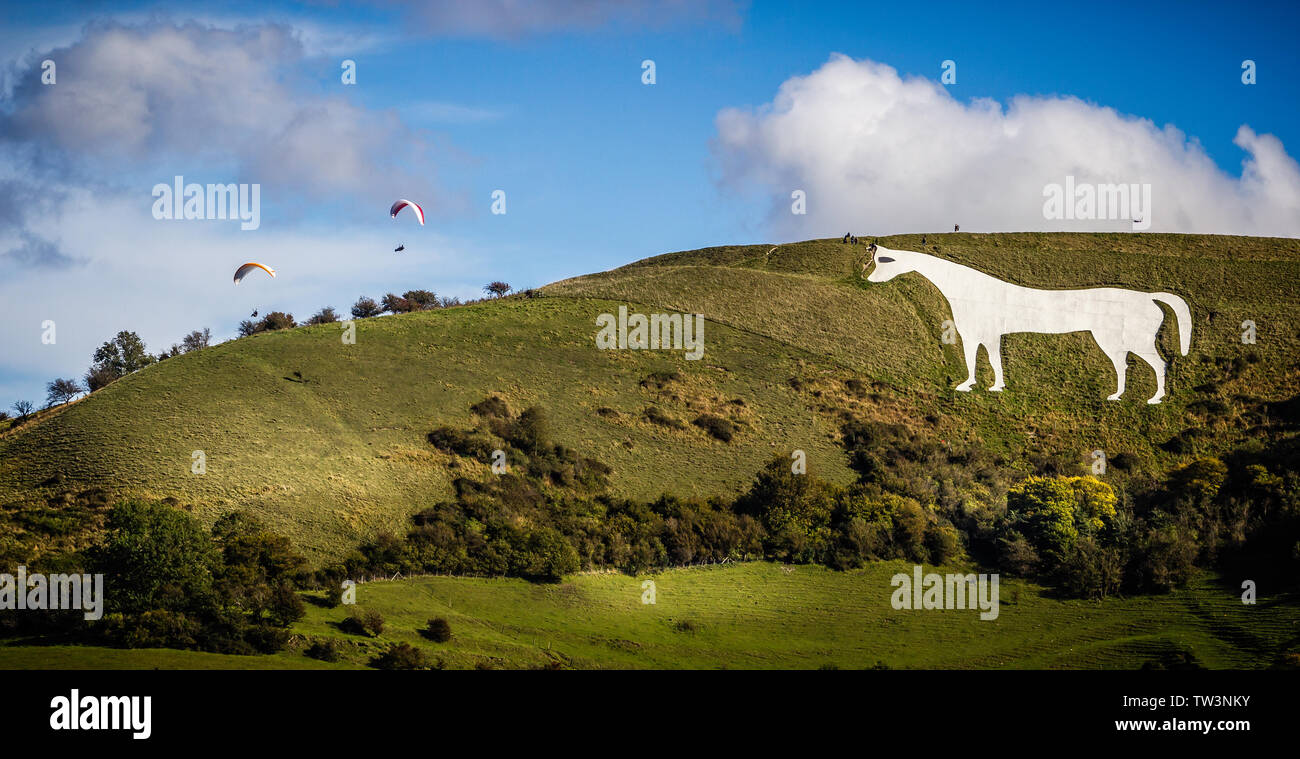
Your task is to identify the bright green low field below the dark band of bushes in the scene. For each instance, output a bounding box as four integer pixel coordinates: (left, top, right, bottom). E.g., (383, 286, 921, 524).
(0, 561, 1300, 669)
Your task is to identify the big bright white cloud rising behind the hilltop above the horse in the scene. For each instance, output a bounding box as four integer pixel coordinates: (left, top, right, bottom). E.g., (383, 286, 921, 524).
(714, 55, 1300, 237)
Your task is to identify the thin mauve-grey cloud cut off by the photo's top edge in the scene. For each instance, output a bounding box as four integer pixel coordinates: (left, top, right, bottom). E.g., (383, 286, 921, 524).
(381, 0, 749, 38)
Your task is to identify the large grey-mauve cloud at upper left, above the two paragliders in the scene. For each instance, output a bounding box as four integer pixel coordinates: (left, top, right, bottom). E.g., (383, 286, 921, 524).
(0, 22, 437, 209)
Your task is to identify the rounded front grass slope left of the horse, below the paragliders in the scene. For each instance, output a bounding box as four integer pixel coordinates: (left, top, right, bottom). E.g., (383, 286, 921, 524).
(0, 299, 850, 558)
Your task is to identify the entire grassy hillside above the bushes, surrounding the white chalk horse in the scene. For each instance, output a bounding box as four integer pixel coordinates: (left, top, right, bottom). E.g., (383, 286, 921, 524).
(0, 234, 1300, 559)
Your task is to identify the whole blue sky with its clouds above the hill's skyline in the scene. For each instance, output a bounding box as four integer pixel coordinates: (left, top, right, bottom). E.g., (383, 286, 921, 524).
(0, 1, 1300, 405)
